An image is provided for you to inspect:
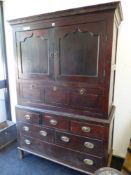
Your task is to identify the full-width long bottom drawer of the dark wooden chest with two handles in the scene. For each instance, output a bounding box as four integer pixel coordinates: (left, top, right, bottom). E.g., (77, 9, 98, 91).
(19, 137, 104, 172)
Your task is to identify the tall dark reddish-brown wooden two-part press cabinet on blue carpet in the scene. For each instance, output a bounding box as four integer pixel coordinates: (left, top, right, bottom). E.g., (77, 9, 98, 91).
(10, 2, 122, 174)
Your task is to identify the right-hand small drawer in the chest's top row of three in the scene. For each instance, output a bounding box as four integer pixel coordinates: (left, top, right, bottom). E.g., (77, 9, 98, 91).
(71, 121, 104, 139)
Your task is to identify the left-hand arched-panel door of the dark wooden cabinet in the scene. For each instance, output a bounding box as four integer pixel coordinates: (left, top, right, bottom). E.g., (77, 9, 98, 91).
(16, 29, 53, 79)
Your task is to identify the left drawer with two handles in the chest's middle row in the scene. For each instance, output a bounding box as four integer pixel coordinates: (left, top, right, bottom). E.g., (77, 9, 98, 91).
(17, 122, 54, 143)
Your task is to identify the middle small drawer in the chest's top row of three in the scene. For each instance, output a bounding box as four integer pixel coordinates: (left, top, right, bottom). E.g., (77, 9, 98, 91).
(42, 113, 69, 130)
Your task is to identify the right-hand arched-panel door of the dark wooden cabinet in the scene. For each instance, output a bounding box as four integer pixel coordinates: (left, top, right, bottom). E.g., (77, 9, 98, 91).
(54, 21, 106, 83)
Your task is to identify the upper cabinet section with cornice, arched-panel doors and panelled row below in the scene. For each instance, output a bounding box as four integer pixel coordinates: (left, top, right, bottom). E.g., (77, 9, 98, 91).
(10, 2, 122, 118)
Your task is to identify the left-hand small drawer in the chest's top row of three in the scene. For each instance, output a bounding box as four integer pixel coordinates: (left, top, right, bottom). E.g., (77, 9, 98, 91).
(16, 109, 40, 124)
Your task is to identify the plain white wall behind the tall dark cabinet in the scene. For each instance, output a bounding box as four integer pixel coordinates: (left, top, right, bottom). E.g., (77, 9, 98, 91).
(4, 0, 131, 157)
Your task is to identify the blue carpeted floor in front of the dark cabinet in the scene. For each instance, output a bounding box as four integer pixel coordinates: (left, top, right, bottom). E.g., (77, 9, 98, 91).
(0, 142, 121, 175)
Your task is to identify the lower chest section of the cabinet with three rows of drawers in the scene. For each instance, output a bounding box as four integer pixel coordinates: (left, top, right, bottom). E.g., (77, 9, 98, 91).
(16, 108, 111, 173)
